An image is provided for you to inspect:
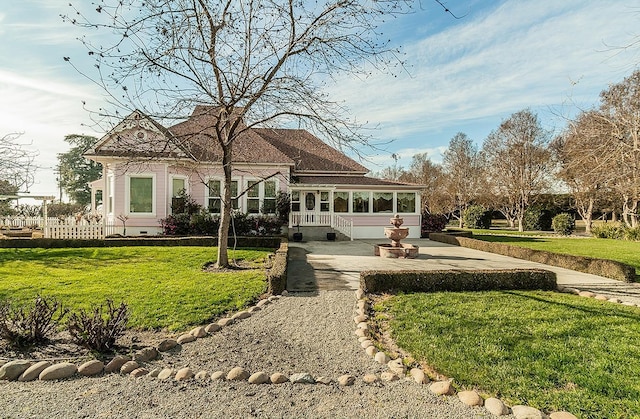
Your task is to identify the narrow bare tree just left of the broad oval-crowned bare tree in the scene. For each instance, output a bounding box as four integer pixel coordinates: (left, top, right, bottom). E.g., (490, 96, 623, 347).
(442, 132, 482, 227)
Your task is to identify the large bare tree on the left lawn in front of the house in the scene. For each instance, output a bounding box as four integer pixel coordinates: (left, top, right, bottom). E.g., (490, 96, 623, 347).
(65, 0, 410, 267)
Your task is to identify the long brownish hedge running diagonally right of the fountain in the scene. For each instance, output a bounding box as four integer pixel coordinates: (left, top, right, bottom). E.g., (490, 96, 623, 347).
(429, 233, 636, 282)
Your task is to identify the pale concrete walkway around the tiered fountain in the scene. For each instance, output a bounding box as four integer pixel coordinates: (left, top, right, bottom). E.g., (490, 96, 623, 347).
(287, 239, 640, 305)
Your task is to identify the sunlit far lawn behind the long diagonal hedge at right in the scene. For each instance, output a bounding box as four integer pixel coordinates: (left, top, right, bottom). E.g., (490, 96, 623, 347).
(473, 236, 640, 275)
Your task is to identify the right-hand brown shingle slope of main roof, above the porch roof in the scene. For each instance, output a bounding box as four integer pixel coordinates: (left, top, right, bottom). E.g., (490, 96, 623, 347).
(254, 128, 369, 174)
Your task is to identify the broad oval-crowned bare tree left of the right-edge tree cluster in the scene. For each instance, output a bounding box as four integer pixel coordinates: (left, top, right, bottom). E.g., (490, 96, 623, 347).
(482, 110, 552, 231)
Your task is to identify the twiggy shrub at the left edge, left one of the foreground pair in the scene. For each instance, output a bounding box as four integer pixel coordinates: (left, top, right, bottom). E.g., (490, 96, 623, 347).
(0, 296, 68, 347)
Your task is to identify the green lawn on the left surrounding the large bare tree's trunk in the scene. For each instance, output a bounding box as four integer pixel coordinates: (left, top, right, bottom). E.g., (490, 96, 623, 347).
(0, 247, 270, 330)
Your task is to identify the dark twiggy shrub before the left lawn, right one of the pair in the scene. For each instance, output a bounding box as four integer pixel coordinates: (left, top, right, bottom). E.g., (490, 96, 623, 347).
(68, 300, 129, 352)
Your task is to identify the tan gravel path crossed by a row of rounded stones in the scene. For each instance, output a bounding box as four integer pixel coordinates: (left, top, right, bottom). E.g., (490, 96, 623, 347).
(0, 291, 508, 418)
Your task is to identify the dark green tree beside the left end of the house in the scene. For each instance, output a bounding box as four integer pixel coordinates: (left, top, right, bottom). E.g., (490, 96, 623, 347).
(58, 134, 102, 206)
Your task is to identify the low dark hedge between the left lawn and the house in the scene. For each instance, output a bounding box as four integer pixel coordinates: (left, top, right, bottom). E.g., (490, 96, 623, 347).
(0, 236, 282, 249)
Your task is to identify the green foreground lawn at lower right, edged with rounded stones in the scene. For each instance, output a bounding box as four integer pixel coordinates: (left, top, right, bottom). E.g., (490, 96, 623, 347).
(374, 291, 640, 418)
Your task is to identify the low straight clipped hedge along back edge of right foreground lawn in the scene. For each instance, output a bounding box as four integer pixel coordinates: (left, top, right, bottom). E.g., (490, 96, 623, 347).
(360, 269, 557, 293)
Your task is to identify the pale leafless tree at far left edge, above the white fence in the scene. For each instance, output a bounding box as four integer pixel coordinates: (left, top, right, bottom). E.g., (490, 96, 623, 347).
(0, 132, 38, 192)
